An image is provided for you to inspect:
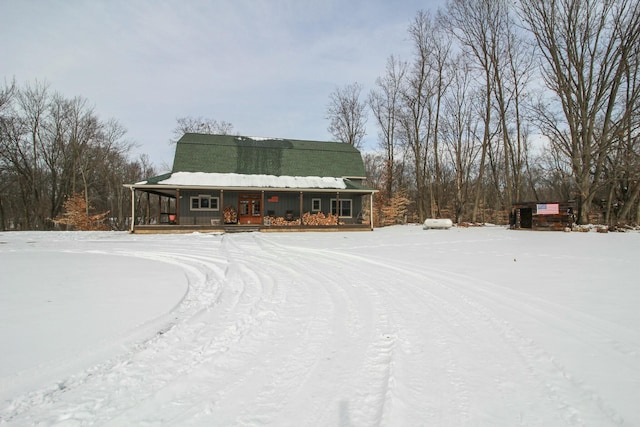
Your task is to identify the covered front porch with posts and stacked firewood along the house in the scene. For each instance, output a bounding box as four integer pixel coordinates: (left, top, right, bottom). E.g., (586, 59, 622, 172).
(129, 184, 374, 233)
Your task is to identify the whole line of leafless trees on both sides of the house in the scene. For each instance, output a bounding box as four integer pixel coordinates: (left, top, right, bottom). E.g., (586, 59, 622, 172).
(5, 0, 640, 229)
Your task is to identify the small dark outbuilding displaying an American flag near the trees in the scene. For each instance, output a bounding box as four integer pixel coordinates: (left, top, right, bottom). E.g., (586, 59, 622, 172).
(509, 201, 576, 231)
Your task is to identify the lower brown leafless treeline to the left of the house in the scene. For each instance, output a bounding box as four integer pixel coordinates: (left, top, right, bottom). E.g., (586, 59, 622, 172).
(0, 82, 155, 230)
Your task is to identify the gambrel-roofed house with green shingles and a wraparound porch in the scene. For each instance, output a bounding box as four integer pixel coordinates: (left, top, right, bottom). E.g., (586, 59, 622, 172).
(125, 133, 376, 233)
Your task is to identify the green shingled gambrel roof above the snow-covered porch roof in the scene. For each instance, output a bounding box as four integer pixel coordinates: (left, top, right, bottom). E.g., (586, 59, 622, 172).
(172, 133, 365, 178)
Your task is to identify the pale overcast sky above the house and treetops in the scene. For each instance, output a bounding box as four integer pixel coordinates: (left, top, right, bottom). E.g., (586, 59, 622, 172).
(0, 0, 445, 169)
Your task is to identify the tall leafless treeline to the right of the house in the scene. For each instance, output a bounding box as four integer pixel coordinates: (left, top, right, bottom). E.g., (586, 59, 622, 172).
(328, 0, 640, 224)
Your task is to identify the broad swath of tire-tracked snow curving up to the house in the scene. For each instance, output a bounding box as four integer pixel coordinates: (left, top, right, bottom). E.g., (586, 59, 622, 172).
(0, 233, 632, 426)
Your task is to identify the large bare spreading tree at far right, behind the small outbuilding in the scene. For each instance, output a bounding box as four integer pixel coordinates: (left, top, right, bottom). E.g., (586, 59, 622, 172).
(520, 0, 640, 223)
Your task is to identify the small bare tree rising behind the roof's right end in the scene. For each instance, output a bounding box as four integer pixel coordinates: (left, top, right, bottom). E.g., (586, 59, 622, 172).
(326, 83, 367, 148)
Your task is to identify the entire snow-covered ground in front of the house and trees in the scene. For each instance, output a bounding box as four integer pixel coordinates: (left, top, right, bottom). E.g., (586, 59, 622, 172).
(0, 226, 640, 427)
